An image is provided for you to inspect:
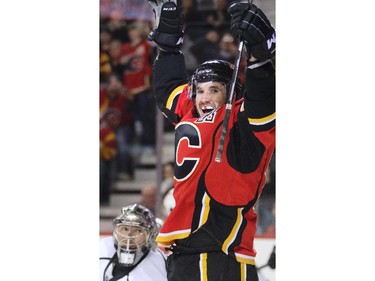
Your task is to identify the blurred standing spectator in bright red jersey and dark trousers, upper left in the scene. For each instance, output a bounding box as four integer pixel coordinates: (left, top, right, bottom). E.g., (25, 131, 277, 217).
(120, 21, 156, 153)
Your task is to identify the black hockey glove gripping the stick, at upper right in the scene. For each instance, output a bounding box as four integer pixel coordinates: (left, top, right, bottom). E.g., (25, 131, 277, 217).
(228, 1, 276, 61)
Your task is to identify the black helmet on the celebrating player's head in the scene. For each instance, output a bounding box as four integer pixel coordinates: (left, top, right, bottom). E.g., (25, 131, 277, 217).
(188, 60, 242, 100)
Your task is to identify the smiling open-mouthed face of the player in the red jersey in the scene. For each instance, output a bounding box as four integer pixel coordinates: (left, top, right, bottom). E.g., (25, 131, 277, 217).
(195, 82, 227, 117)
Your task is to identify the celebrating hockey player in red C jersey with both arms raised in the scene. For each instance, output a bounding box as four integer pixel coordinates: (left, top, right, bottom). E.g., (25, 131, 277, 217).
(148, 0, 275, 281)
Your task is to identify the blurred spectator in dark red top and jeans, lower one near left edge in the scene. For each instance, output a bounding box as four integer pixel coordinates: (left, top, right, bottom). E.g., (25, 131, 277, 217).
(100, 75, 134, 181)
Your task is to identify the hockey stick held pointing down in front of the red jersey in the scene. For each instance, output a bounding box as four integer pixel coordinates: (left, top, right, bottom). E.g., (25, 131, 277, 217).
(215, 0, 253, 163)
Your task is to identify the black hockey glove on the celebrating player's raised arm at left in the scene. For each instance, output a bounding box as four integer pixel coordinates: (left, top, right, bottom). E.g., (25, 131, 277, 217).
(147, 0, 184, 53)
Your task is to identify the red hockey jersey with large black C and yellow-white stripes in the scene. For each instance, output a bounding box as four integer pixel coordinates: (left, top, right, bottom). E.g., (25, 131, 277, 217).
(154, 55, 275, 264)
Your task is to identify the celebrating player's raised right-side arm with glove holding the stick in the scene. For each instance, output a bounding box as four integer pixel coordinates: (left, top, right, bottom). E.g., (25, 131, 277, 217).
(228, 1, 276, 131)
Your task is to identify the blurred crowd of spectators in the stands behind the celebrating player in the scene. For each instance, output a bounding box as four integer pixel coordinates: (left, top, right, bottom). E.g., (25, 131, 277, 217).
(99, 0, 275, 236)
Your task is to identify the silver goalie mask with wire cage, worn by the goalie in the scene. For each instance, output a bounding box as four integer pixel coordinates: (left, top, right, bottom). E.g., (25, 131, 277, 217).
(113, 204, 159, 267)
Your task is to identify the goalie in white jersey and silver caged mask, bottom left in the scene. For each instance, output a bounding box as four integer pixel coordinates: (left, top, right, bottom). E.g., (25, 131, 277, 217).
(99, 204, 167, 281)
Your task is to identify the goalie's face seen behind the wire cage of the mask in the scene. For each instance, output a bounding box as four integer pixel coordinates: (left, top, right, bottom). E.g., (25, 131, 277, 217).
(116, 225, 147, 249)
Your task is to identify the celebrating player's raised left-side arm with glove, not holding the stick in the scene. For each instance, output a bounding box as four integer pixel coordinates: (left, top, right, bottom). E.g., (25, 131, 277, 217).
(148, 0, 188, 123)
